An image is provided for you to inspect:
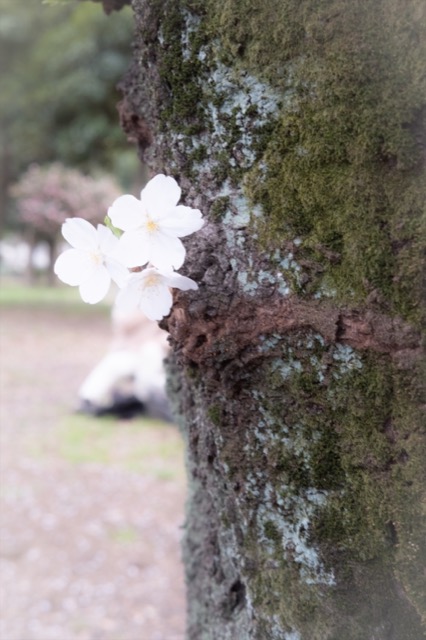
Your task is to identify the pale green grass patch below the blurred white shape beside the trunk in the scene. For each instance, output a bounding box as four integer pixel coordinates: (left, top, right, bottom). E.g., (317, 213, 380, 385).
(31, 414, 184, 480)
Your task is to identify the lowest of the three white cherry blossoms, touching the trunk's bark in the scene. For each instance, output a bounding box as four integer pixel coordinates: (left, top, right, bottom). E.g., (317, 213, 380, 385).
(116, 267, 198, 320)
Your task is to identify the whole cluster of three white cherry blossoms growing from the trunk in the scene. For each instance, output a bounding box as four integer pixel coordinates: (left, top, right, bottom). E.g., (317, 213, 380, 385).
(54, 174, 204, 320)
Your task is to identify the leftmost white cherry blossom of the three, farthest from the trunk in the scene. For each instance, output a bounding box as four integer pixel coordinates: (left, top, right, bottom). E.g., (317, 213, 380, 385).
(54, 218, 129, 304)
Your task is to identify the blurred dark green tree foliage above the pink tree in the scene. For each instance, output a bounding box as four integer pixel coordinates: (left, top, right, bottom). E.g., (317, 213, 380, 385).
(0, 0, 136, 234)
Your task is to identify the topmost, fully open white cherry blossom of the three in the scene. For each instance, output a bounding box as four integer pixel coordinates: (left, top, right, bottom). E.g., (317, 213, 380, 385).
(108, 174, 204, 271)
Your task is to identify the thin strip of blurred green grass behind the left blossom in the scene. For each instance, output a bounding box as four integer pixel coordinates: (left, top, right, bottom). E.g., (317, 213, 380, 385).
(0, 278, 110, 311)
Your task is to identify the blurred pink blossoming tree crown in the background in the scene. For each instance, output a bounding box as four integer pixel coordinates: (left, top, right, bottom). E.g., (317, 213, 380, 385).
(11, 163, 121, 240)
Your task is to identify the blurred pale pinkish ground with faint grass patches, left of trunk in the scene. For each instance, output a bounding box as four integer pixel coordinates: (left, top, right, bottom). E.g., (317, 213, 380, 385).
(0, 306, 185, 640)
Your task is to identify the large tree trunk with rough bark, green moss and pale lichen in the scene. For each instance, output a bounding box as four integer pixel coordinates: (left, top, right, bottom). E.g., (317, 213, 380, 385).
(121, 0, 426, 640)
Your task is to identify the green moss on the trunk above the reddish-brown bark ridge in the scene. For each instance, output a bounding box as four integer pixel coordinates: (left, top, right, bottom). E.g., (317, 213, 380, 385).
(231, 1, 426, 321)
